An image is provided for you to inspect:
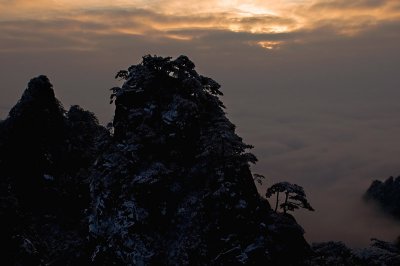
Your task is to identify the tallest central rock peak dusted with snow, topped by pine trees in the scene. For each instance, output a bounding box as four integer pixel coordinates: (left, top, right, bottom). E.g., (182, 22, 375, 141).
(90, 56, 309, 265)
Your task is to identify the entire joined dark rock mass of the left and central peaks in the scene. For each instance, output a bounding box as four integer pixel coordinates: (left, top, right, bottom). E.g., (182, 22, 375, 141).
(0, 56, 311, 265)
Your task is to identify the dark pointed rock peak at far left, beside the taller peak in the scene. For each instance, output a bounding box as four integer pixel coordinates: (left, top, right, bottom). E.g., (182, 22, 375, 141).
(0, 76, 108, 265)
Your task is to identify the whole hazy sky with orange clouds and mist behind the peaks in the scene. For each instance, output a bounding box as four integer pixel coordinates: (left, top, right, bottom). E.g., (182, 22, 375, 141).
(0, 0, 400, 247)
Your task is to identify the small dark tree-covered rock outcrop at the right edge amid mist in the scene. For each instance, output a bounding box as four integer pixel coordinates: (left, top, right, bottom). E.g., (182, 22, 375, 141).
(364, 176, 400, 219)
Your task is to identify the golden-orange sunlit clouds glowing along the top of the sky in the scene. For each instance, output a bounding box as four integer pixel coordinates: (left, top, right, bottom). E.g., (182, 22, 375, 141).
(0, 0, 400, 50)
